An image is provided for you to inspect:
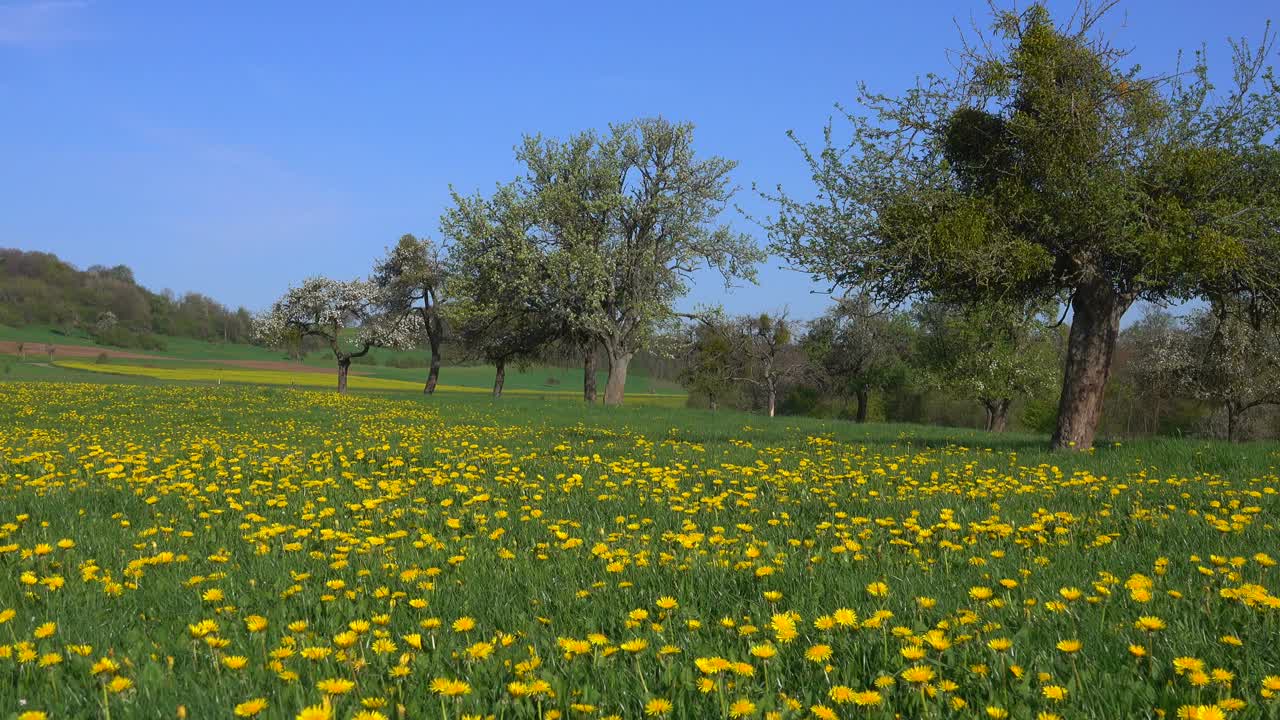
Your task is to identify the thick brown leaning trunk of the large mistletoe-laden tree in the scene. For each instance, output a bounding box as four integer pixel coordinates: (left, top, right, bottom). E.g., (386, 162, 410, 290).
(1050, 283, 1133, 451)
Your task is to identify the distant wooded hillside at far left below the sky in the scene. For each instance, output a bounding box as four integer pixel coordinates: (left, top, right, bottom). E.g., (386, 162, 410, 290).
(0, 249, 252, 348)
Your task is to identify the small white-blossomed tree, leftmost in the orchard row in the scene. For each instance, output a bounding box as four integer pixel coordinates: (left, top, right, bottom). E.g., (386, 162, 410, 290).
(255, 277, 421, 393)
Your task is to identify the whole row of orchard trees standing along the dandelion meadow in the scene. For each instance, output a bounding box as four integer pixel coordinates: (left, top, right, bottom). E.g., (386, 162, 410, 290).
(252, 3, 1280, 450)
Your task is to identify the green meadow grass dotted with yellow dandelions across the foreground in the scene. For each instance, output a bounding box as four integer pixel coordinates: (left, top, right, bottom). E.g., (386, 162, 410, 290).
(0, 379, 1280, 720)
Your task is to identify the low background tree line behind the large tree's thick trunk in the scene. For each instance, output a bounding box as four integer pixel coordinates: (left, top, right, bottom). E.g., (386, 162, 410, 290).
(673, 296, 1280, 441)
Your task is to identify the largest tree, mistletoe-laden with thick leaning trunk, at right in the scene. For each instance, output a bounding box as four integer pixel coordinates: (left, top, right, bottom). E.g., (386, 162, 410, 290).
(768, 3, 1280, 450)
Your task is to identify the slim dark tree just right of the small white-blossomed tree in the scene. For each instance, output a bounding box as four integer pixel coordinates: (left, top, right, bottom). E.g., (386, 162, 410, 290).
(374, 234, 445, 395)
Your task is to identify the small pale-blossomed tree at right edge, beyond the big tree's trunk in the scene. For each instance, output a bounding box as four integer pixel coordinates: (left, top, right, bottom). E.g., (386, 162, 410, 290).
(1164, 299, 1280, 442)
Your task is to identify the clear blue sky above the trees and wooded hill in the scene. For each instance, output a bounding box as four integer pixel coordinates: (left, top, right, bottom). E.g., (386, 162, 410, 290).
(0, 0, 1280, 318)
